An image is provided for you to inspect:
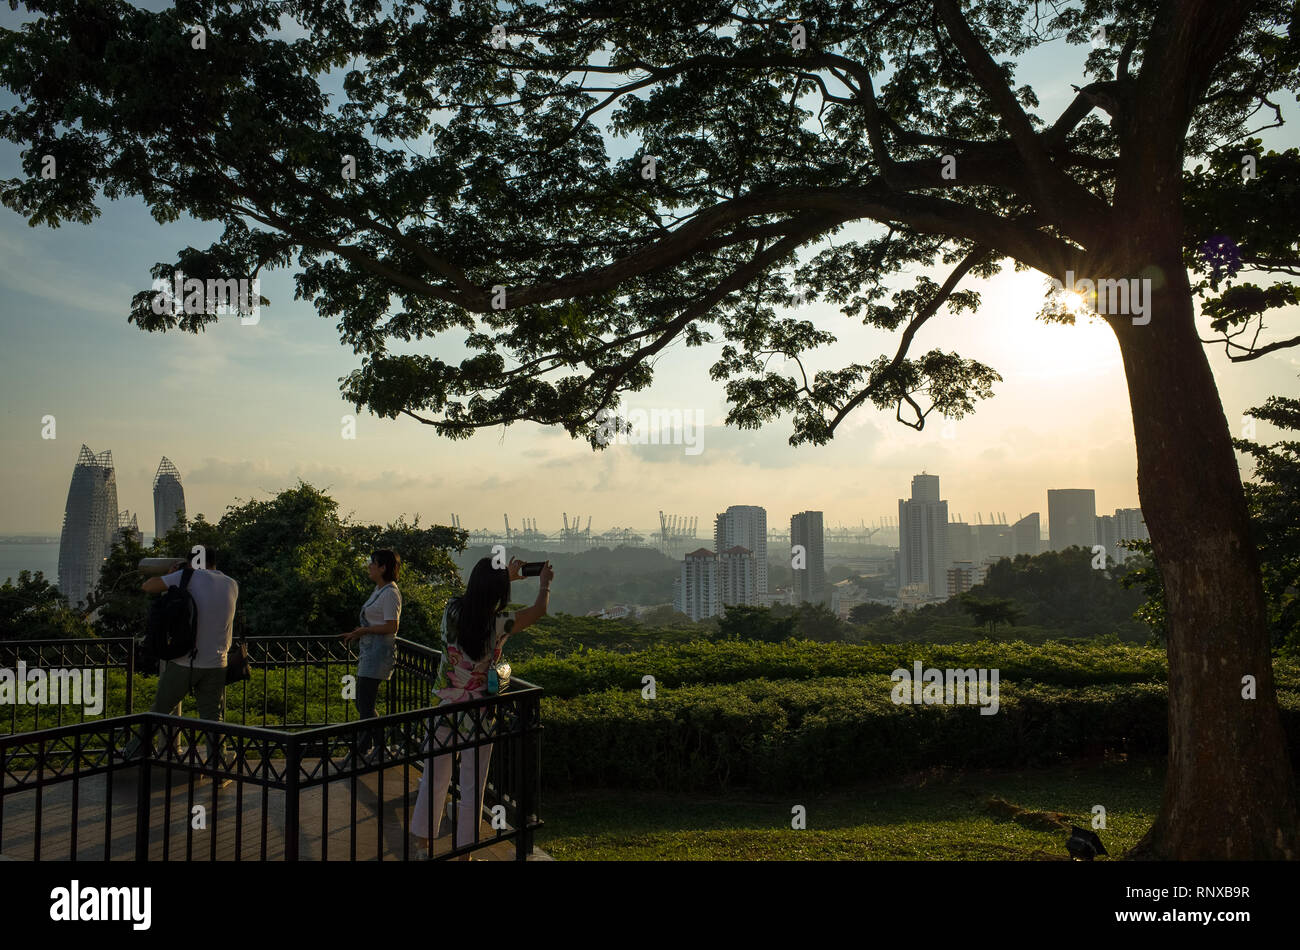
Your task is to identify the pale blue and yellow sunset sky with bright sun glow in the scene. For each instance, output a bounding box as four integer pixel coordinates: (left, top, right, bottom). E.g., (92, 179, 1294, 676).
(0, 9, 1300, 537)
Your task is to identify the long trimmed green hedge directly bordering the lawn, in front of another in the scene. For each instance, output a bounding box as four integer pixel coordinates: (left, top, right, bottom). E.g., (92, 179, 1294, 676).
(542, 676, 1300, 791)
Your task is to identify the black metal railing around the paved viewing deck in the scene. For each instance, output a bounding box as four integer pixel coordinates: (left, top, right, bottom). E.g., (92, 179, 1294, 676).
(0, 637, 542, 860)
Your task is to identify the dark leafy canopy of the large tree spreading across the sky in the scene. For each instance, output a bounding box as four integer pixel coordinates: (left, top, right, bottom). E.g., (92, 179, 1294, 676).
(0, 0, 1297, 446)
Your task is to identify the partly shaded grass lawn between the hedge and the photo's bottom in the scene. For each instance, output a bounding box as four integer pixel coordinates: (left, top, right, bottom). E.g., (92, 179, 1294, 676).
(537, 759, 1164, 860)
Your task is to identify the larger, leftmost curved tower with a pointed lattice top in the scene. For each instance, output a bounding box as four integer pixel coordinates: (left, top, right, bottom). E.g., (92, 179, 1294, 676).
(59, 446, 118, 604)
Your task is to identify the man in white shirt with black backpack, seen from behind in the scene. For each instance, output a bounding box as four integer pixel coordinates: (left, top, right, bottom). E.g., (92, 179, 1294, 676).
(124, 548, 239, 765)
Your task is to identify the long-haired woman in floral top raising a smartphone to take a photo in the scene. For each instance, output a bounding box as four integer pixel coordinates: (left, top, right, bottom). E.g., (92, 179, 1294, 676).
(411, 558, 555, 858)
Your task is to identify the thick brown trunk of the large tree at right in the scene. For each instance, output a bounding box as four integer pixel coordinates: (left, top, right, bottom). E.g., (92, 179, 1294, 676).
(1112, 239, 1300, 860)
